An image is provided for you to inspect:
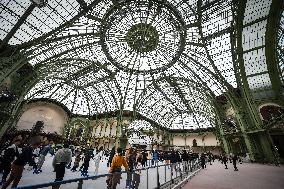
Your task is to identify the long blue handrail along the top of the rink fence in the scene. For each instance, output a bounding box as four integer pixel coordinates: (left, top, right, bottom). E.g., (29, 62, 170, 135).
(11, 161, 199, 189)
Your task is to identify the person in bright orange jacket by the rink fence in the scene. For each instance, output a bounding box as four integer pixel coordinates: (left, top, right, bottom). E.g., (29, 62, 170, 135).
(107, 148, 128, 189)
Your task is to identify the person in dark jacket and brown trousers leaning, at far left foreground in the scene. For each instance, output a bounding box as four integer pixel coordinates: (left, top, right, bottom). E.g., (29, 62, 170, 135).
(1, 137, 41, 189)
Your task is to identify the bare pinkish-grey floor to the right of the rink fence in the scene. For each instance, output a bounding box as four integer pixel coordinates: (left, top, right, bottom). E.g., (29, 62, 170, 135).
(183, 161, 284, 189)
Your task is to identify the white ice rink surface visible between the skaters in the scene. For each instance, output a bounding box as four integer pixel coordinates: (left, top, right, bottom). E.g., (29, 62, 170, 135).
(0, 154, 182, 189)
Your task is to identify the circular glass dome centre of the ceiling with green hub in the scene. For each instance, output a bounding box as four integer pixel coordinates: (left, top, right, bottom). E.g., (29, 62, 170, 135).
(100, 0, 186, 73)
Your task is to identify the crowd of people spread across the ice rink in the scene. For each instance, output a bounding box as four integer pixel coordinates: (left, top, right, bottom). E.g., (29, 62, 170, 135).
(0, 136, 242, 189)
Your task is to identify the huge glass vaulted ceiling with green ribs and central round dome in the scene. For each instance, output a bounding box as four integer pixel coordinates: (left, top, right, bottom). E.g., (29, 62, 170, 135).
(0, 0, 278, 129)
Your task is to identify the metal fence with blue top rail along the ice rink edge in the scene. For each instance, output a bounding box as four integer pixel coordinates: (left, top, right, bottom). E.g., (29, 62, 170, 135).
(13, 160, 200, 189)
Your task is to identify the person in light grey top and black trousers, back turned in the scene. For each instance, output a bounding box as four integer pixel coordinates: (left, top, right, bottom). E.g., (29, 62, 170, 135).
(52, 143, 72, 189)
